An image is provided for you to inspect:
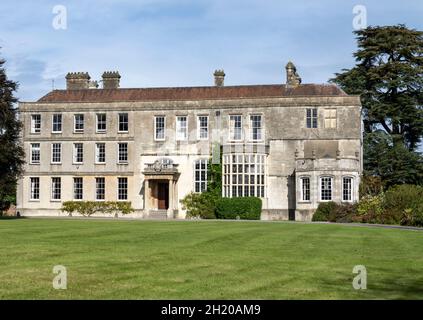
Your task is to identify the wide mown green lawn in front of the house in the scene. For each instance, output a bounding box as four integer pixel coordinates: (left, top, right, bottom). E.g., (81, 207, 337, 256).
(0, 219, 423, 299)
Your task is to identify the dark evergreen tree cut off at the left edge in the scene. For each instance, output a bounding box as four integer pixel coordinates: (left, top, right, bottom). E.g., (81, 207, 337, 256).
(0, 55, 24, 210)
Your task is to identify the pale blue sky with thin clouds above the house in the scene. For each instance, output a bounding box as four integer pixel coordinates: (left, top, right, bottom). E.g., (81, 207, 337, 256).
(0, 0, 423, 101)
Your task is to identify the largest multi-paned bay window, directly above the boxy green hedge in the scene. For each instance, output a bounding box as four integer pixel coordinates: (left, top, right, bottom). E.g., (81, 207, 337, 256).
(223, 154, 265, 198)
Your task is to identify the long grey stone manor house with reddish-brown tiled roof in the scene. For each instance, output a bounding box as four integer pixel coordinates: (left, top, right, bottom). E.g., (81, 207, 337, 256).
(17, 62, 362, 220)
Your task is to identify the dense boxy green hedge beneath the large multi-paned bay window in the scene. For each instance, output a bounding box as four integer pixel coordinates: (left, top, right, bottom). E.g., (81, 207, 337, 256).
(216, 197, 262, 220)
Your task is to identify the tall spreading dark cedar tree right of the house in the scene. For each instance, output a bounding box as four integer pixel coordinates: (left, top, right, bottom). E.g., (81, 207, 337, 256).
(330, 25, 423, 185)
